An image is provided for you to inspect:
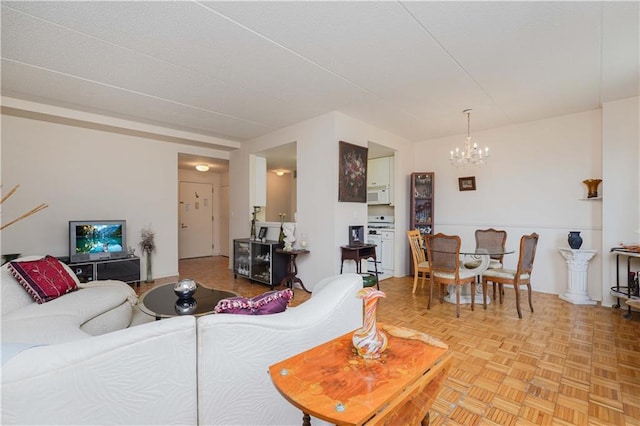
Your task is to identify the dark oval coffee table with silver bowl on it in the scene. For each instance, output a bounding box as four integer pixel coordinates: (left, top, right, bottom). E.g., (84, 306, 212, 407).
(138, 283, 238, 320)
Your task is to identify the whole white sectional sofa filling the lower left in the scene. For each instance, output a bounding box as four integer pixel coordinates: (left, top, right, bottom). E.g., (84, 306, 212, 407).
(0, 256, 362, 425)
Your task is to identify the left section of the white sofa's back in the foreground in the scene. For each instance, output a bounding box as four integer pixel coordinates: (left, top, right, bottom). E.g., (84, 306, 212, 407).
(1, 316, 197, 424)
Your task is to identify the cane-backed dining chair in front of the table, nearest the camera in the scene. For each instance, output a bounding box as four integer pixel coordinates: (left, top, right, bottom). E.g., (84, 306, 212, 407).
(426, 233, 476, 318)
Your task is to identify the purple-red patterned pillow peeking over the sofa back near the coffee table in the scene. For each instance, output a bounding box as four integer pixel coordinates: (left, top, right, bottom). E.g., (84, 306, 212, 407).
(214, 288, 293, 315)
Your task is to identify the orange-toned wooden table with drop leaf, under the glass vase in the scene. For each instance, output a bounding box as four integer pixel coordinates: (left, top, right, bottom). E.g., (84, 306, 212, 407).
(269, 324, 451, 425)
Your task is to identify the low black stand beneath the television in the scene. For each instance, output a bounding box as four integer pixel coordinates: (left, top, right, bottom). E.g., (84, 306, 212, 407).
(60, 256, 140, 285)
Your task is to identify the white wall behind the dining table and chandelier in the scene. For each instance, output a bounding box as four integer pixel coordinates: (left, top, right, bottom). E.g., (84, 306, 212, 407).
(414, 110, 608, 300)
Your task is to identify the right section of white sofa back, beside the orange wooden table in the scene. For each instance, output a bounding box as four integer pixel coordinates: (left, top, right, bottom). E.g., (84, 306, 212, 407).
(197, 274, 362, 425)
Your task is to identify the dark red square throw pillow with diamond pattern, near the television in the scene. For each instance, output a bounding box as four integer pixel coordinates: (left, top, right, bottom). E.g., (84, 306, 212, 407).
(8, 256, 78, 303)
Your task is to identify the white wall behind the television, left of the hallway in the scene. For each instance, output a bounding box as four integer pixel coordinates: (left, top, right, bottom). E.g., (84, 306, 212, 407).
(1, 113, 228, 278)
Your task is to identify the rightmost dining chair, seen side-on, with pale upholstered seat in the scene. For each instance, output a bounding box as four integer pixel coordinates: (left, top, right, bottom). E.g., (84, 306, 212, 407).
(482, 232, 538, 318)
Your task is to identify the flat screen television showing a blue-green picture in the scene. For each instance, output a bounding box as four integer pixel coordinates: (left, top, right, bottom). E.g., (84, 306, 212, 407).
(69, 220, 127, 263)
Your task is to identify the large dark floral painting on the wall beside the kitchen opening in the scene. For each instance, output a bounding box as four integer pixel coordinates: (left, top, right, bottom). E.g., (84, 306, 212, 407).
(338, 141, 369, 203)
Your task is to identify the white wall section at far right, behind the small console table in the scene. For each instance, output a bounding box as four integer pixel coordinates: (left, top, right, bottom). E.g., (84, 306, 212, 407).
(601, 97, 640, 306)
